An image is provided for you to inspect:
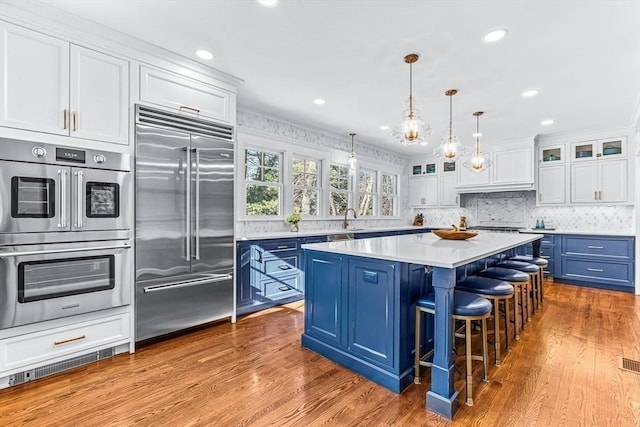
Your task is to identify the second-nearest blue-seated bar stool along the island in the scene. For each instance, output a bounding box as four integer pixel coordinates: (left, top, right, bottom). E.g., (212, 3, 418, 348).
(456, 276, 514, 366)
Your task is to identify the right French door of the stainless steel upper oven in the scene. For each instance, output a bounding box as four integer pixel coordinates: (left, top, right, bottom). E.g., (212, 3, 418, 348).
(71, 168, 133, 231)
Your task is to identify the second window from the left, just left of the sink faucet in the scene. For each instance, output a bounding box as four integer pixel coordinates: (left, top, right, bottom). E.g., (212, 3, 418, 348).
(291, 157, 320, 216)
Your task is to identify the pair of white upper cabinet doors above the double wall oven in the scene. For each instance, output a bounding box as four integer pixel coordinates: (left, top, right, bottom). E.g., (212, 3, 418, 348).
(0, 21, 129, 145)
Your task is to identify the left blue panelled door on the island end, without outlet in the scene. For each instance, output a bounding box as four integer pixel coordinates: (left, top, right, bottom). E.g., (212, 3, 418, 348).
(304, 251, 347, 347)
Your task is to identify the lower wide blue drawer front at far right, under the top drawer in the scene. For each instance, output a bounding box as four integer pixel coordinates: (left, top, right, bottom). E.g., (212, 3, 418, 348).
(562, 258, 633, 286)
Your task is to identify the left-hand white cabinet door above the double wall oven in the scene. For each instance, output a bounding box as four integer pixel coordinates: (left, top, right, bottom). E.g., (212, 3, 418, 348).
(0, 21, 69, 135)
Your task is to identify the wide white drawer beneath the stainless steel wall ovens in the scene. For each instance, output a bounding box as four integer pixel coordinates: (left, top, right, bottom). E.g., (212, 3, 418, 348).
(0, 313, 129, 371)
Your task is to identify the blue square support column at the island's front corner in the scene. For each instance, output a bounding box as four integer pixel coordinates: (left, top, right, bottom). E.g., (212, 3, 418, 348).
(427, 267, 459, 419)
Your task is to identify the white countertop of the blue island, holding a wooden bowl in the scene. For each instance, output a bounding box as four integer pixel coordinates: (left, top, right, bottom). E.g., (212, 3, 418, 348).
(302, 231, 542, 268)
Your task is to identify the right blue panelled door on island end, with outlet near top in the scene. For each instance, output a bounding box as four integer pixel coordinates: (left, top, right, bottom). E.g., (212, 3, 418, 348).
(347, 257, 400, 368)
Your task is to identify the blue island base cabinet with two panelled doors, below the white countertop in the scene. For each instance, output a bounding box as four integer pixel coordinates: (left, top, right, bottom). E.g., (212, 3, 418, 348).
(302, 250, 430, 393)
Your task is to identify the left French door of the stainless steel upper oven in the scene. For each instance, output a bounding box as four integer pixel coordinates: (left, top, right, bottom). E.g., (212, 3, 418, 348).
(0, 160, 71, 234)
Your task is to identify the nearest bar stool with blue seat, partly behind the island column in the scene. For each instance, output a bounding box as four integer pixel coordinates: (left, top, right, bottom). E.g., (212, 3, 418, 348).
(413, 291, 491, 406)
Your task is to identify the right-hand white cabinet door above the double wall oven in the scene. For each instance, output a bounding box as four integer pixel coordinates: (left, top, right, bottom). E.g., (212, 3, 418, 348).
(69, 45, 129, 144)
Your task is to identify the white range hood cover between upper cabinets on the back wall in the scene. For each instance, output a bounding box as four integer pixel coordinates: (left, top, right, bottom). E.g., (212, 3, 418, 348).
(457, 144, 534, 193)
